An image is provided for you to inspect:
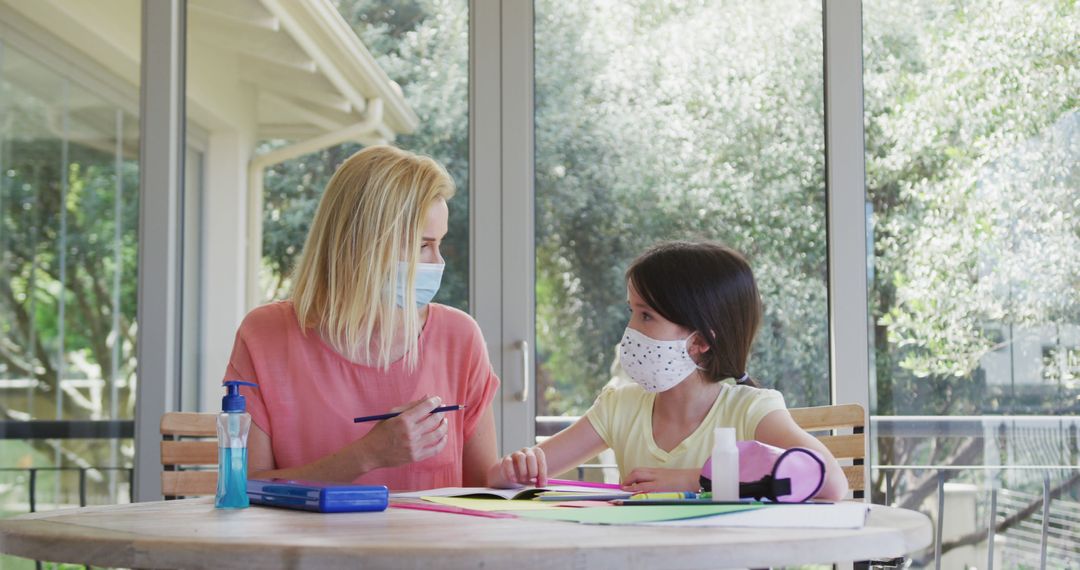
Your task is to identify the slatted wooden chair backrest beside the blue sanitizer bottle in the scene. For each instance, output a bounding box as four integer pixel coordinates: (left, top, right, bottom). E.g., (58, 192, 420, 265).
(161, 411, 217, 499)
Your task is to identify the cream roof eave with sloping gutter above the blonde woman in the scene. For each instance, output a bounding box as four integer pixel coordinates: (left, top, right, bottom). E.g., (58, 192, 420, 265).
(188, 0, 419, 143)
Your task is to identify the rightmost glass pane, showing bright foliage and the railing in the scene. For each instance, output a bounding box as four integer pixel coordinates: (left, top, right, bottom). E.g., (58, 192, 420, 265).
(863, 0, 1080, 568)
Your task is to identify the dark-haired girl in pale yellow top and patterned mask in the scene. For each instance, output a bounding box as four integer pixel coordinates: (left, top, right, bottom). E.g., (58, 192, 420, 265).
(488, 242, 848, 500)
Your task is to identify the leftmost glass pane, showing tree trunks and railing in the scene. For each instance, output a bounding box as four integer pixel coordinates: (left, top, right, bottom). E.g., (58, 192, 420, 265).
(0, 0, 140, 548)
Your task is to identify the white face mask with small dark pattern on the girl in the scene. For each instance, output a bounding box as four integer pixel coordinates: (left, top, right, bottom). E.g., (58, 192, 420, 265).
(619, 327, 698, 392)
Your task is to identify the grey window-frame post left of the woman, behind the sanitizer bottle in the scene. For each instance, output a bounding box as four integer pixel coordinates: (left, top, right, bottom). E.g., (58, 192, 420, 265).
(134, 0, 187, 501)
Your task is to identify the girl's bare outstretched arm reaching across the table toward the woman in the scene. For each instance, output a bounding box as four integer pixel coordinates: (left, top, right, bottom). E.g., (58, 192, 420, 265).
(487, 418, 607, 487)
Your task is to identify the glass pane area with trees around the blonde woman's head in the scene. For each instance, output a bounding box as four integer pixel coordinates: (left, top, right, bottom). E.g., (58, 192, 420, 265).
(259, 0, 469, 311)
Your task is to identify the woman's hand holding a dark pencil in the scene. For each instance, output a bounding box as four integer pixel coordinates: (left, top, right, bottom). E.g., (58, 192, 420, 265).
(354, 396, 448, 471)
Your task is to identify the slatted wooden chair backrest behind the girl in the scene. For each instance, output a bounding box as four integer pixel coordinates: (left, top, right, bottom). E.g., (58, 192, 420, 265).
(787, 404, 866, 499)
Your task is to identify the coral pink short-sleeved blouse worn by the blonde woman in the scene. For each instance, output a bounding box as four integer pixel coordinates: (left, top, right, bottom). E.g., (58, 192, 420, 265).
(225, 301, 499, 490)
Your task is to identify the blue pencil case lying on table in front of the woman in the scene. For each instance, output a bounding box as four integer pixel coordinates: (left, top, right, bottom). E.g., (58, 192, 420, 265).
(247, 479, 390, 513)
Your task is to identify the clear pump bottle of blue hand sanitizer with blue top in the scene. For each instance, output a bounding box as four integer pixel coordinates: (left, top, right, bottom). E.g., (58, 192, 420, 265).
(214, 380, 258, 508)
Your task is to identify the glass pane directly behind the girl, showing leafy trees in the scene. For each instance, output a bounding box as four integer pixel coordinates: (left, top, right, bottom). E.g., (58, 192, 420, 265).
(536, 0, 829, 455)
